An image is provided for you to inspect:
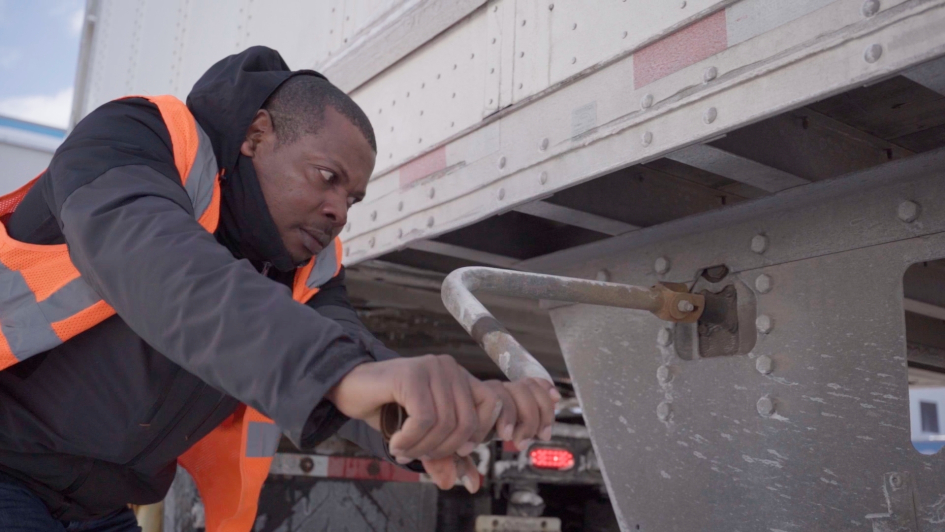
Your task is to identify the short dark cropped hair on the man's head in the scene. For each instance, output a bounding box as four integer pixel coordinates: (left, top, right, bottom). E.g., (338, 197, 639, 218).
(263, 75, 377, 153)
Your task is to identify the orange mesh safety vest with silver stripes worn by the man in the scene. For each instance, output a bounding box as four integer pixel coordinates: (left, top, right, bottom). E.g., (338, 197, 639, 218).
(0, 96, 341, 532)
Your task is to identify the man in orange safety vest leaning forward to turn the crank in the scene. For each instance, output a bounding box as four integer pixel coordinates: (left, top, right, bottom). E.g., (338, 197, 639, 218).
(0, 47, 560, 531)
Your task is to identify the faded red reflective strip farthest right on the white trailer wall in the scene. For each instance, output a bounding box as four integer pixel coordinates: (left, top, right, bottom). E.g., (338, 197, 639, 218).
(633, 9, 728, 89)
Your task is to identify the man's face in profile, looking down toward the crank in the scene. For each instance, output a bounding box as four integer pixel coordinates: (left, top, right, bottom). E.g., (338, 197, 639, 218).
(240, 107, 375, 263)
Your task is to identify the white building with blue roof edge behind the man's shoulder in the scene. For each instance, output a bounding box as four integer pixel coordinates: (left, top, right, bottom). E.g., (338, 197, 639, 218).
(0, 116, 66, 194)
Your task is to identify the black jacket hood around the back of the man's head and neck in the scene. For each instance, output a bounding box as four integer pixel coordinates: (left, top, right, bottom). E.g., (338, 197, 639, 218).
(187, 46, 326, 271)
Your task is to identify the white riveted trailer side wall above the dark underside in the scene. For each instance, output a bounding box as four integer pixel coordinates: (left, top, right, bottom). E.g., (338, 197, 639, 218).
(76, 0, 945, 267)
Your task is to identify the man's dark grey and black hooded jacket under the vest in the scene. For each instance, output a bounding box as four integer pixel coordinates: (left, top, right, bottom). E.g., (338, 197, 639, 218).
(0, 47, 397, 520)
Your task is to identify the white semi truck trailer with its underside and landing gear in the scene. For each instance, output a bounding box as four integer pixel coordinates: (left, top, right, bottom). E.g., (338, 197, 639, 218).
(66, 0, 945, 532)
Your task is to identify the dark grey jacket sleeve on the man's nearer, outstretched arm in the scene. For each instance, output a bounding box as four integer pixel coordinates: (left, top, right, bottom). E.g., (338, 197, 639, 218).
(46, 101, 371, 445)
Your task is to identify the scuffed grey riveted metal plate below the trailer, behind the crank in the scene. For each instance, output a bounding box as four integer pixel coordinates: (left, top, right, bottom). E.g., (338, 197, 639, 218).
(547, 150, 945, 532)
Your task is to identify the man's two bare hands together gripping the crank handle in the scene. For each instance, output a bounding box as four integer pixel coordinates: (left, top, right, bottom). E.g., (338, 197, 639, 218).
(326, 355, 561, 492)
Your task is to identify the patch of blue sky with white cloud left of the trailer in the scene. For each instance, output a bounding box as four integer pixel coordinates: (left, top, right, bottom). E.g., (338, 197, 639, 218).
(0, 0, 85, 128)
